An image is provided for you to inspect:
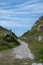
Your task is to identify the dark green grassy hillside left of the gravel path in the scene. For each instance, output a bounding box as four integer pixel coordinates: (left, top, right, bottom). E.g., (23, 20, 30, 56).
(0, 26, 19, 50)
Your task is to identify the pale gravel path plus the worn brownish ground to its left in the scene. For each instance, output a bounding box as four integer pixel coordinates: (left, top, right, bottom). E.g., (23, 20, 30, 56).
(0, 39, 34, 59)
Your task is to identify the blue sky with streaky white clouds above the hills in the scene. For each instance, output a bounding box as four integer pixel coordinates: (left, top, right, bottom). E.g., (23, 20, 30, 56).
(0, 0, 43, 36)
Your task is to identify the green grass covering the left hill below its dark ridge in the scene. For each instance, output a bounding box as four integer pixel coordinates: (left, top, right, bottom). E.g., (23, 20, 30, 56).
(0, 33, 20, 51)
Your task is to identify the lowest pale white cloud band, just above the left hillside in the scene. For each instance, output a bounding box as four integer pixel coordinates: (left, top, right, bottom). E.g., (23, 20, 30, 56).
(0, 21, 29, 28)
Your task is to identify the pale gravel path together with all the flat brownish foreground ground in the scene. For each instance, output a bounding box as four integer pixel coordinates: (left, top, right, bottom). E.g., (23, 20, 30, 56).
(0, 39, 43, 65)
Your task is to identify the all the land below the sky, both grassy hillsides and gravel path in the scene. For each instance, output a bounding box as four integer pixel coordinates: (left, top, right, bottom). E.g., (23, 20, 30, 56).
(0, 16, 43, 65)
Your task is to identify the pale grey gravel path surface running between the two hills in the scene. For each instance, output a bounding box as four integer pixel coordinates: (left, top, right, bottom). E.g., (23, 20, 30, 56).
(12, 40, 34, 59)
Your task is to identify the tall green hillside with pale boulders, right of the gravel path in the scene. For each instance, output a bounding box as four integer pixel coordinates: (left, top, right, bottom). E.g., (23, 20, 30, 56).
(20, 16, 43, 63)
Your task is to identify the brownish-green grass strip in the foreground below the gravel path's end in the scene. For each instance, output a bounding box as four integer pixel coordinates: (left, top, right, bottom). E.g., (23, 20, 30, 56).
(0, 59, 34, 65)
